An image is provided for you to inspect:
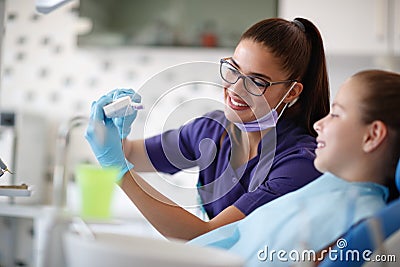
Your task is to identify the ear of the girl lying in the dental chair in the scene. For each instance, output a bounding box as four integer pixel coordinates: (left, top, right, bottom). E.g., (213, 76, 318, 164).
(363, 121, 387, 153)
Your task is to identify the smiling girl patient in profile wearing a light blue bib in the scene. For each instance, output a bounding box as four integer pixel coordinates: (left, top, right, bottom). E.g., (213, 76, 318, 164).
(189, 70, 400, 266)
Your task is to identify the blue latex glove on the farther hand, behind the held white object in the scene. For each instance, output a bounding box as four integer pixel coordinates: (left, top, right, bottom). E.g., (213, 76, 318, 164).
(107, 89, 142, 139)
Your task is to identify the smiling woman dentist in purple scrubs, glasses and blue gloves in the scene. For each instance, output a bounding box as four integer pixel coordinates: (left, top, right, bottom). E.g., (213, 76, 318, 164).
(86, 18, 329, 240)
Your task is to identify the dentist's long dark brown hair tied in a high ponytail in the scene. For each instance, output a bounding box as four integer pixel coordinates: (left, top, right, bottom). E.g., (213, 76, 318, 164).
(240, 18, 329, 136)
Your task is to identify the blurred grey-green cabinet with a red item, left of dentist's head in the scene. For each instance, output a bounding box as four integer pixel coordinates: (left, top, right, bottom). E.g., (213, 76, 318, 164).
(78, 0, 278, 48)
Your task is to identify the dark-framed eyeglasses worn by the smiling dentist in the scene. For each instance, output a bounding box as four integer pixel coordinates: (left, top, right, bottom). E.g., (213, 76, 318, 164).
(219, 57, 296, 96)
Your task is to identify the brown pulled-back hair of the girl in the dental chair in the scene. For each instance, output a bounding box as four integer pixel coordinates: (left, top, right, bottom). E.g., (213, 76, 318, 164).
(352, 70, 400, 202)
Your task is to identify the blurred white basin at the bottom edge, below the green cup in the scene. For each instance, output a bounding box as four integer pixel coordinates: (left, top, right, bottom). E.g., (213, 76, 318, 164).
(63, 231, 244, 267)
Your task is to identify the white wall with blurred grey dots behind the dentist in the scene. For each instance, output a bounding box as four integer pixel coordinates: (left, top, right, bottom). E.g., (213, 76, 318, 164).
(0, 0, 232, 214)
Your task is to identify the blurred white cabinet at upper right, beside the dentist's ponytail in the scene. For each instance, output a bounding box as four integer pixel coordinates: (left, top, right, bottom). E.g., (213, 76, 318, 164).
(278, 0, 400, 55)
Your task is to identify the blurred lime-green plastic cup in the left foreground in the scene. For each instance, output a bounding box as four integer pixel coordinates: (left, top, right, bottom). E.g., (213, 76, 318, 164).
(76, 164, 119, 220)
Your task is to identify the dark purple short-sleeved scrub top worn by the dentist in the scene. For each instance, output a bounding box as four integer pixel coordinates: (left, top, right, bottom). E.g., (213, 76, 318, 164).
(145, 110, 321, 219)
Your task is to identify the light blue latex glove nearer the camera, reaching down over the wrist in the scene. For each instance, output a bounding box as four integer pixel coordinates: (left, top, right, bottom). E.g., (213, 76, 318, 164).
(85, 95, 133, 180)
